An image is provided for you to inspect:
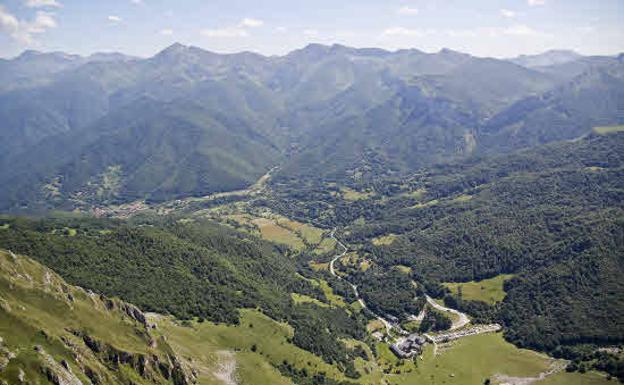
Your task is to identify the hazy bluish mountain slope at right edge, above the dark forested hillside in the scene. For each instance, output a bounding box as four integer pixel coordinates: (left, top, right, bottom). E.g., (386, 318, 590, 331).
(480, 63, 624, 152)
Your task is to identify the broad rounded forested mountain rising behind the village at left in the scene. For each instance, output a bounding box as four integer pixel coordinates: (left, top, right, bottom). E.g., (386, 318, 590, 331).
(3, 96, 279, 208)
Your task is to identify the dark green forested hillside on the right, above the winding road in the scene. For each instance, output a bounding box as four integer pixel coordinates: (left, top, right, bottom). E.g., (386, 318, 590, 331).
(268, 130, 624, 376)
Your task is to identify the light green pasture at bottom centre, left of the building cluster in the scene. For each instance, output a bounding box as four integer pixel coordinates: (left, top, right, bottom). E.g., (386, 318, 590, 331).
(150, 310, 390, 385)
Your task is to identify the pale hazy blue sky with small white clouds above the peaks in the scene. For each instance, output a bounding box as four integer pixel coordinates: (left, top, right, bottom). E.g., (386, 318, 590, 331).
(0, 0, 624, 57)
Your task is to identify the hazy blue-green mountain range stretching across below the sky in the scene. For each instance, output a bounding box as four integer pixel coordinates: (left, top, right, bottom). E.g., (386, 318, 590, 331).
(0, 44, 624, 211)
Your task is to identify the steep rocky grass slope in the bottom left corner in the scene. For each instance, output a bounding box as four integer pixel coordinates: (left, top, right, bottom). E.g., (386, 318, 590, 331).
(0, 251, 190, 385)
